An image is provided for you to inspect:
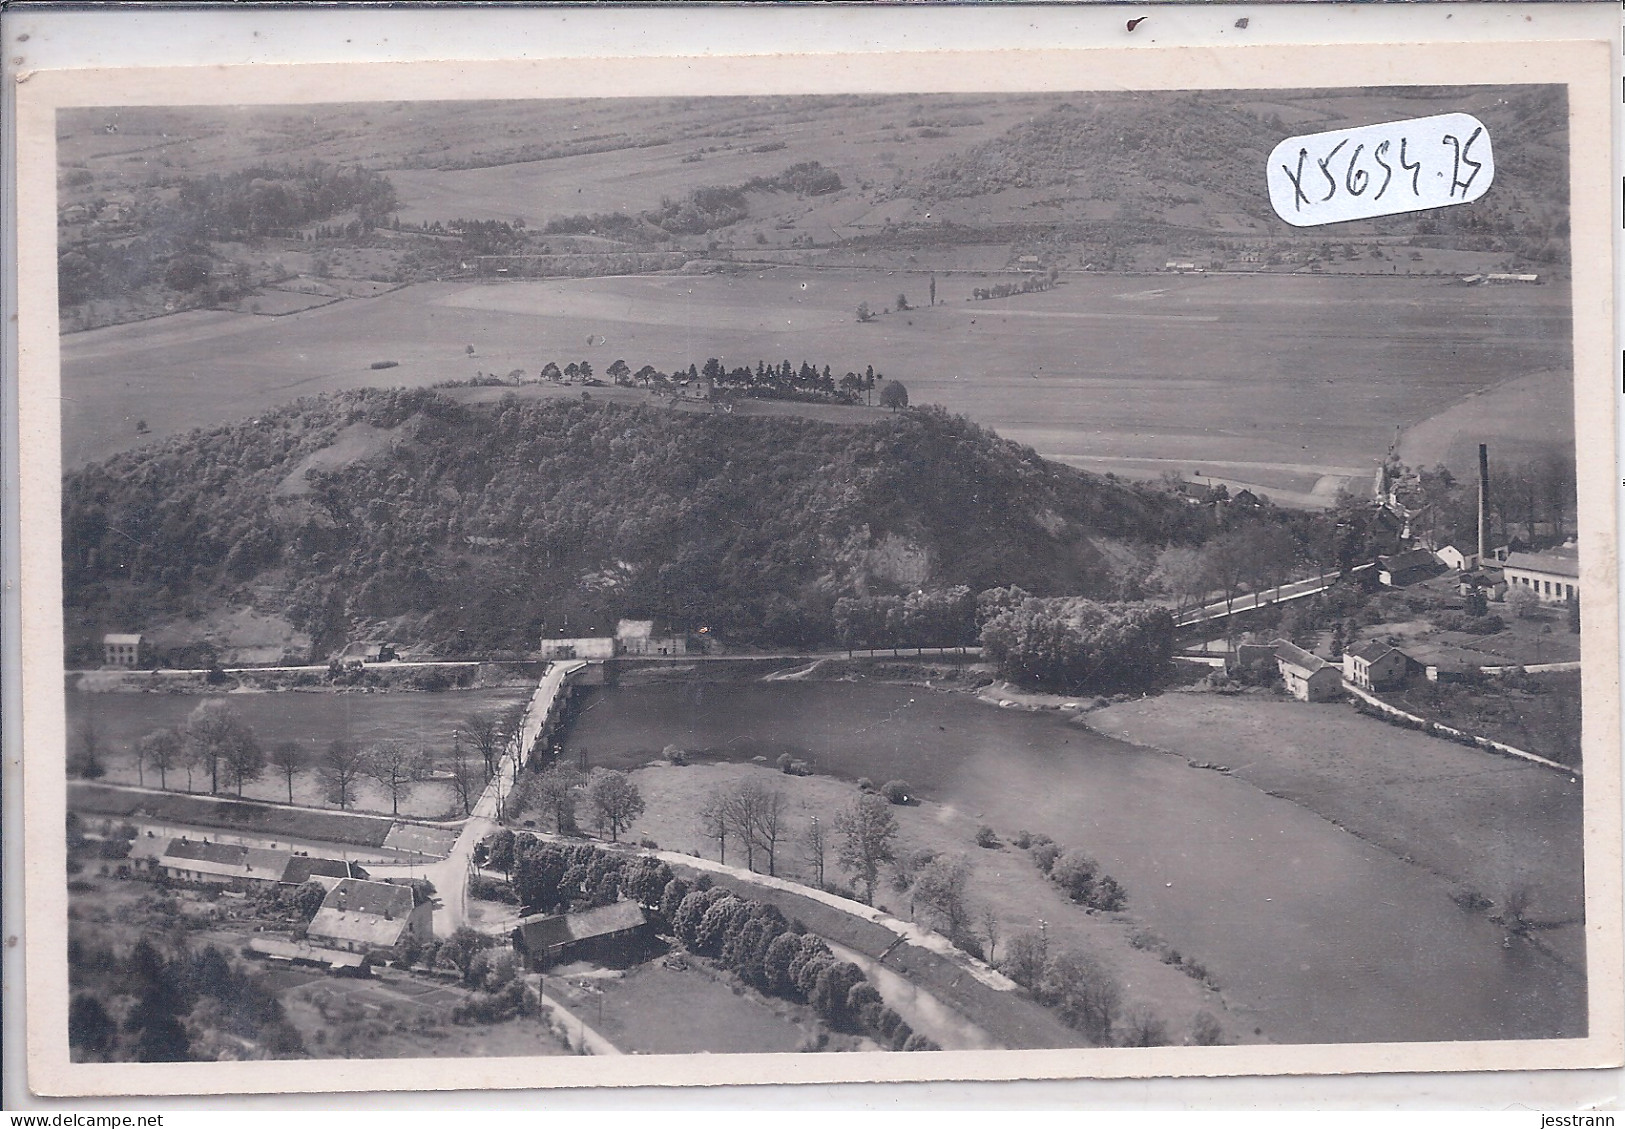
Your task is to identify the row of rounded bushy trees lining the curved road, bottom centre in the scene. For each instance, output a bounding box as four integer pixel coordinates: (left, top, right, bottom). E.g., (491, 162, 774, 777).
(661, 879, 939, 1051)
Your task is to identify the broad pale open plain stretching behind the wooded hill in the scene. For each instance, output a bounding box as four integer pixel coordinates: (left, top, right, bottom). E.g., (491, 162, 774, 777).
(63, 268, 1568, 500)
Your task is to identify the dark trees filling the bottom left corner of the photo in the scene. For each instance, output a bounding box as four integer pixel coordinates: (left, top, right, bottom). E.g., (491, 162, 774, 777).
(68, 937, 304, 1062)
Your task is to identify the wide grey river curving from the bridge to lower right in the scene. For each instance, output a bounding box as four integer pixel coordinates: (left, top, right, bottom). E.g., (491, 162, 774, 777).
(569, 682, 1586, 1043)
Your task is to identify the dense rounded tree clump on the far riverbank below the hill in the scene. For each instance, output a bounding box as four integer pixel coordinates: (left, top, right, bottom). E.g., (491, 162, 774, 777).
(978, 588, 1173, 694)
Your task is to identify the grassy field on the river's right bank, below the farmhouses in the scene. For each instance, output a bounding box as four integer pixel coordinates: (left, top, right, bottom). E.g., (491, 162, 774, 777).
(1087, 694, 1584, 968)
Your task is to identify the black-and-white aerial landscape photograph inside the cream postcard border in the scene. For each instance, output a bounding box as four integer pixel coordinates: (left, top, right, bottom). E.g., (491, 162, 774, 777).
(50, 84, 1586, 1080)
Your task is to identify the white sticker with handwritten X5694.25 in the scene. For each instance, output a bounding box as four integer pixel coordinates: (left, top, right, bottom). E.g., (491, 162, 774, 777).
(1268, 114, 1495, 227)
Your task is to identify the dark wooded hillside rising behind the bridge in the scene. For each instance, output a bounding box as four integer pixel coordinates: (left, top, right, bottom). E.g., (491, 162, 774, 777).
(63, 390, 1201, 663)
